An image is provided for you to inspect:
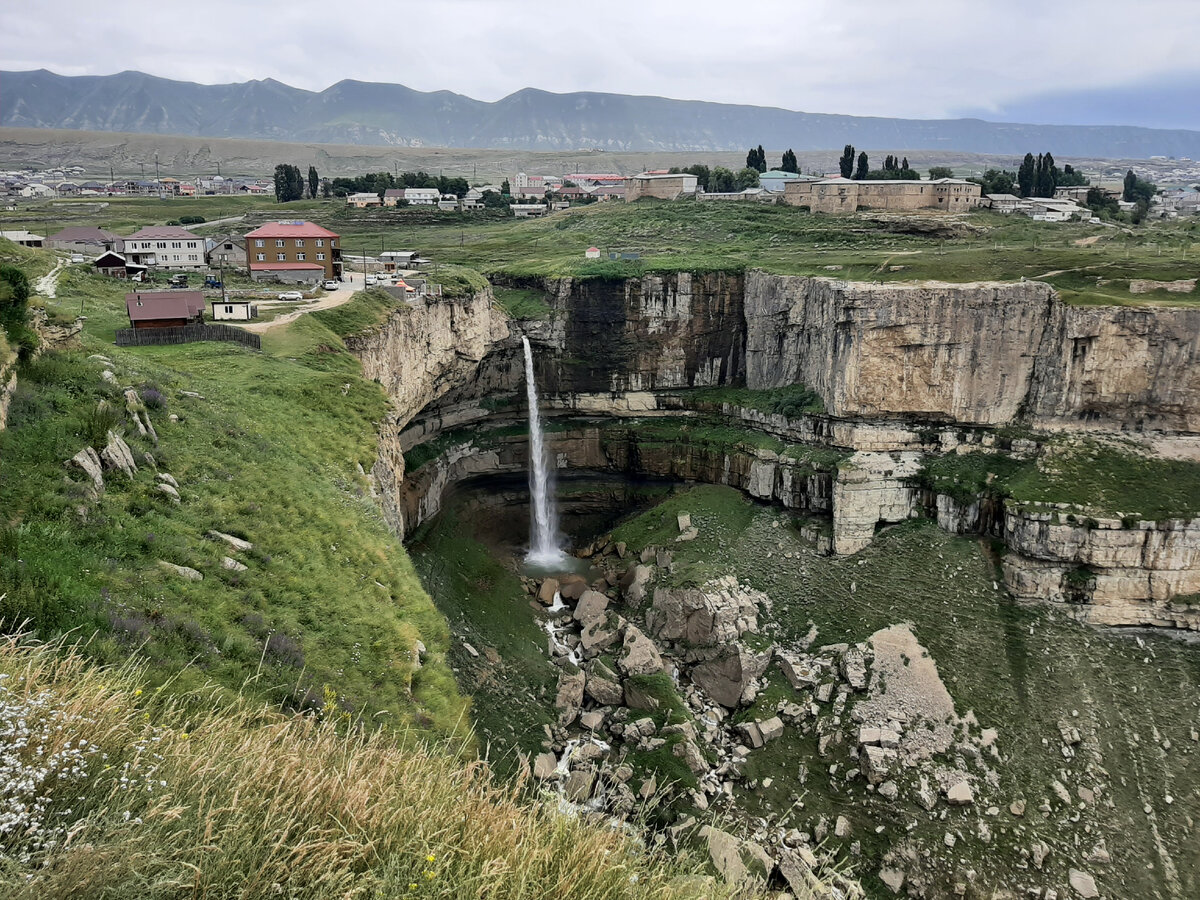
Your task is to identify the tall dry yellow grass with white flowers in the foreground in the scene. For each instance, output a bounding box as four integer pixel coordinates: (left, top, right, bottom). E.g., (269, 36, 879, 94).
(0, 636, 728, 900)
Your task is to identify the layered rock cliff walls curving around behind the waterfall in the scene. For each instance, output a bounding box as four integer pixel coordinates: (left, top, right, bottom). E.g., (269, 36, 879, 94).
(347, 270, 1200, 630)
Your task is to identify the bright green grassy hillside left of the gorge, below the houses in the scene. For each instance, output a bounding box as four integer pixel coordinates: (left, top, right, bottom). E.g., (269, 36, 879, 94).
(0, 259, 466, 731)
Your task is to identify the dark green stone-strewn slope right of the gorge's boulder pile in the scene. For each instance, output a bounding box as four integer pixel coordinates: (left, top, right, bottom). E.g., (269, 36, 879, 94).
(614, 486, 1200, 896)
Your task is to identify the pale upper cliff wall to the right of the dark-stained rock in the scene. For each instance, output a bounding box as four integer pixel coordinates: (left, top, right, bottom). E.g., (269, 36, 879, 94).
(745, 271, 1200, 432)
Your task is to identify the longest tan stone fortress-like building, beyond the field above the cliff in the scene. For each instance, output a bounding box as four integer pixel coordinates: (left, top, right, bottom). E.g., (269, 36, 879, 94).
(784, 178, 983, 212)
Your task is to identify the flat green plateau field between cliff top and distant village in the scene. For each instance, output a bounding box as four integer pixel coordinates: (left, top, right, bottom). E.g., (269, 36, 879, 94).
(9, 197, 1200, 314)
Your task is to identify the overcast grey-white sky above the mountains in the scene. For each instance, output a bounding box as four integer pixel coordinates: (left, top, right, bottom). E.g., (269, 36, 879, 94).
(7, 0, 1200, 127)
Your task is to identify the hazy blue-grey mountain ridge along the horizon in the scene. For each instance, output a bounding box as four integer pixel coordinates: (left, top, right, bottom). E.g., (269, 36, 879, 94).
(7, 70, 1200, 158)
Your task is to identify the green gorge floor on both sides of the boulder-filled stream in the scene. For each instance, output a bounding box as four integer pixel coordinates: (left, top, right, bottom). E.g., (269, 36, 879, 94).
(410, 486, 1200, 898)
